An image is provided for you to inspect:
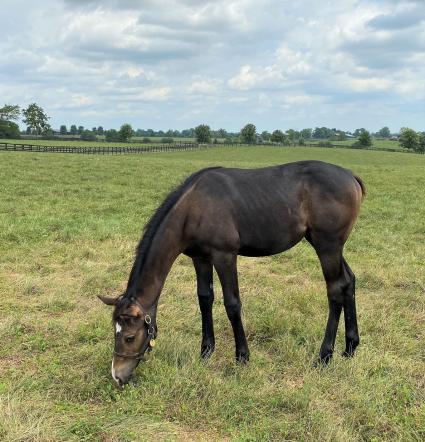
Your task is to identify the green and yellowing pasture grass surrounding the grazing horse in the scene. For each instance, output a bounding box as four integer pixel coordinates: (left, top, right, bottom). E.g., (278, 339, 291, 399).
(0, 147, 425, 442)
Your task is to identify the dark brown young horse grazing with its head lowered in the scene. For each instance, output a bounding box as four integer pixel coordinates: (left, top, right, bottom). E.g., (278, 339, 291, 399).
(99, 161, 365, 386)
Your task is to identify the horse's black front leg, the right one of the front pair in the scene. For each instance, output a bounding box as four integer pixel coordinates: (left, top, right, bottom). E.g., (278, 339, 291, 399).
(213, 252, 249, 363)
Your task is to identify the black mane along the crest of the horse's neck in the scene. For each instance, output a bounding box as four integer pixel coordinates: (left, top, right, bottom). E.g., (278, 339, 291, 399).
(126, 166, 220, 296)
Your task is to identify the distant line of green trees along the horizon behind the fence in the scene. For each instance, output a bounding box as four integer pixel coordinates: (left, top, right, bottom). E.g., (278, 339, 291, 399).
(0, 103, 425, 152)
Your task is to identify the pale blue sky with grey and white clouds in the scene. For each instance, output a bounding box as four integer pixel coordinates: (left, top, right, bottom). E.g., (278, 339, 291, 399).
(0, 0, 425, 132)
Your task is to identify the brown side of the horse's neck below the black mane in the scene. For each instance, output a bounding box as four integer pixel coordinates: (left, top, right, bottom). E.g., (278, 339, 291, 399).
(127, 210, 184, 315)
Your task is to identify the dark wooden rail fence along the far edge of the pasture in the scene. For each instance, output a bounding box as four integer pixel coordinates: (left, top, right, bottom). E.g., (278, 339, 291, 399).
(0, 142, 413, 155)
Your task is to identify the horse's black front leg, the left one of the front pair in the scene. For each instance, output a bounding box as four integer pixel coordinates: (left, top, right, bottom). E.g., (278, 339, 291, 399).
(193, 258, 215, 359)
